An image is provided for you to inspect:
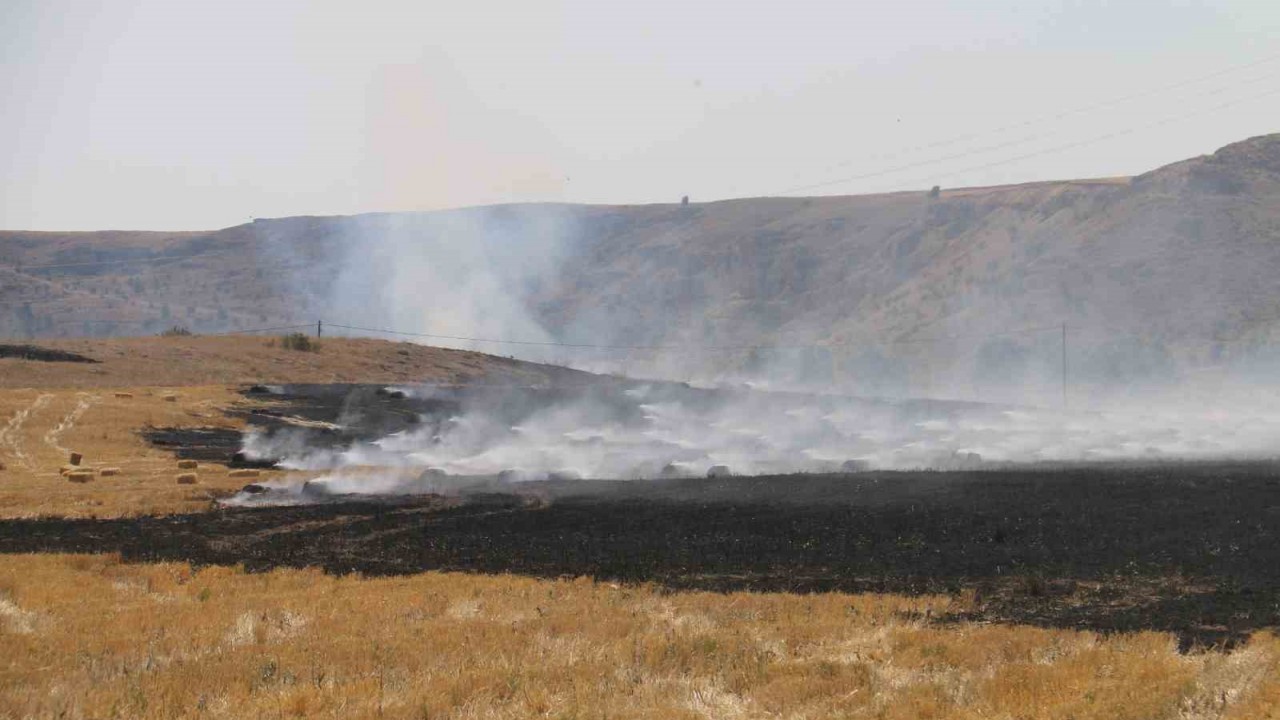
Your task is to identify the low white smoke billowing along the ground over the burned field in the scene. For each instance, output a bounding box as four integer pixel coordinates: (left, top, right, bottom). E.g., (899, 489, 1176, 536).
(225, 382, 1280, 503)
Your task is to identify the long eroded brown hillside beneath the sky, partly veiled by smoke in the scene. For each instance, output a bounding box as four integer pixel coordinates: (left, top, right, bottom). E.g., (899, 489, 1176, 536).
(0, 136, 1280, 400)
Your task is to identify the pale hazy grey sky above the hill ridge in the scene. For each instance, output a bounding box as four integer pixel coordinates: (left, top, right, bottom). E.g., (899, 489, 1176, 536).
(0, 0, 1280, 229)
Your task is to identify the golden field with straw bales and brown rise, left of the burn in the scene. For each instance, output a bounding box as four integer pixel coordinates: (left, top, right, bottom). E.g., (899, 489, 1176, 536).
(0, 337, 581, 518)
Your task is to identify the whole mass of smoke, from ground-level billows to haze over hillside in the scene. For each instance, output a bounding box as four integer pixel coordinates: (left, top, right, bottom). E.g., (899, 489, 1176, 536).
(225, 179, 1280, 504)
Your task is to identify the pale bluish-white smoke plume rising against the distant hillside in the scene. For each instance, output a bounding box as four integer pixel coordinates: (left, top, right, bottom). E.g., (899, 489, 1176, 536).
(253, 205, 580, 360)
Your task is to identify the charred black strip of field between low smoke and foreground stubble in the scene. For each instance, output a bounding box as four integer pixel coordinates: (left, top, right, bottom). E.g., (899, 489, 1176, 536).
(0, 464, 1280, 647)
